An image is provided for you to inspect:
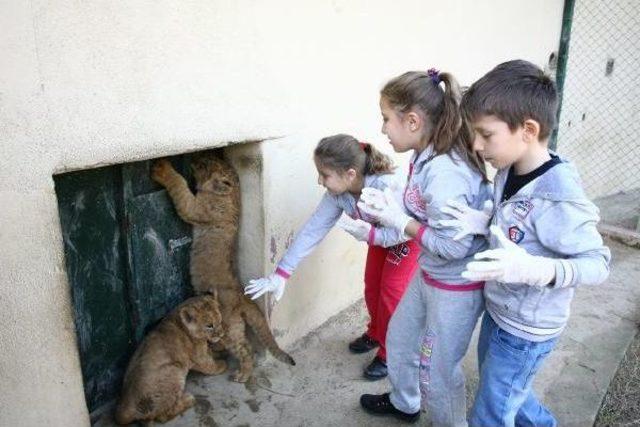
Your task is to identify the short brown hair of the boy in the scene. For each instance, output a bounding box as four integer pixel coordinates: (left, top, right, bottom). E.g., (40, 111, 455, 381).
(462, 59, 558, 141)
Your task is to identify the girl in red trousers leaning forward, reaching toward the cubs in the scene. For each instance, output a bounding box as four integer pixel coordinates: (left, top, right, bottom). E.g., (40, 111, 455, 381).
(245, 135, 420, 380)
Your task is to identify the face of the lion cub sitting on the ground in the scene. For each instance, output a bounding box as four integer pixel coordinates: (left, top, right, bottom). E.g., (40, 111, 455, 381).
(179, 295, 224, 343)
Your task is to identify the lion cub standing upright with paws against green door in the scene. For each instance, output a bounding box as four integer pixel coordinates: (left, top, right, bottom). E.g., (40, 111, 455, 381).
(151, 153, 295, 382)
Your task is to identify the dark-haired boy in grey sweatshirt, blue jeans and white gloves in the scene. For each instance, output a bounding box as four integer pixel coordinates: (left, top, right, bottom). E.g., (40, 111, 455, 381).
(443, 60, 611, 426)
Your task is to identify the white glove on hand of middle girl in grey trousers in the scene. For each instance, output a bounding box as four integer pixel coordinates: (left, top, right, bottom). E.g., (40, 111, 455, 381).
(358, 187, 411, 234)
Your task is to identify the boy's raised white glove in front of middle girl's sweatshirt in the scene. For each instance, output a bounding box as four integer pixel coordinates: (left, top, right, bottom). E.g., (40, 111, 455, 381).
(436, 200, 493, 240)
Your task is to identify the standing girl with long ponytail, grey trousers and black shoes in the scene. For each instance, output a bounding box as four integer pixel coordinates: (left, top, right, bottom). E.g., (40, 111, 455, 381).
(358, 69, 491, 426)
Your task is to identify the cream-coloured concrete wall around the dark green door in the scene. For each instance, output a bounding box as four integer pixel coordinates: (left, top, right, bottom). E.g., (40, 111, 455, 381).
(0, 0, 562, 426)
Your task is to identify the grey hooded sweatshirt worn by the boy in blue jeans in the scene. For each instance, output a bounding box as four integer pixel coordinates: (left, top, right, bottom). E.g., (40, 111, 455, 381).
(484, 162, 611, 342)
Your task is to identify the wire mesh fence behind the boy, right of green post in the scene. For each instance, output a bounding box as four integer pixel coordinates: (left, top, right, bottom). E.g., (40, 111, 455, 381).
(557, 0, 640, 230)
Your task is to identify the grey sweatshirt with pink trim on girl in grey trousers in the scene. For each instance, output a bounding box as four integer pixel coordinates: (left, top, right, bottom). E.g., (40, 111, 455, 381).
(404, 147, 491, 290)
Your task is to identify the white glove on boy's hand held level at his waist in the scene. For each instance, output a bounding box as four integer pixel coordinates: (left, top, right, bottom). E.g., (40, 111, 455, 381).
(462, 225, 557, 287)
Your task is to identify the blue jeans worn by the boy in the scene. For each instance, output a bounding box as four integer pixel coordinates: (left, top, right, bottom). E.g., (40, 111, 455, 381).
(469, 313, 557, 427)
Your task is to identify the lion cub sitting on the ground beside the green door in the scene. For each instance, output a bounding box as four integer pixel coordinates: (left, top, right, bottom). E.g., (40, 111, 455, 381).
(115, 295, 227, 424)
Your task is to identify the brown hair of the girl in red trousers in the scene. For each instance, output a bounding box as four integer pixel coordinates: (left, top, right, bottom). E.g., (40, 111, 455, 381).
(313, 134, 394, 175)
